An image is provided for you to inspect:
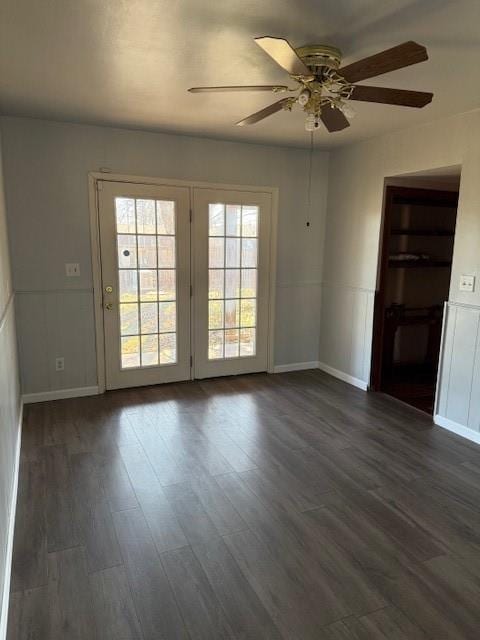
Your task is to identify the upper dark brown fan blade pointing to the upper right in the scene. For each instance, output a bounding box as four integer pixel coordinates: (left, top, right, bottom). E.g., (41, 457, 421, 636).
(338, 41, 428, 82)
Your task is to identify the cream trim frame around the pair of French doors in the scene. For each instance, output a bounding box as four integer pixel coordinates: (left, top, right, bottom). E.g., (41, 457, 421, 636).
(88, 171, 278, 393)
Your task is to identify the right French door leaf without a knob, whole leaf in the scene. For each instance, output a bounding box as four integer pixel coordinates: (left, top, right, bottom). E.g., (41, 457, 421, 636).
(194, 189, 271, 377)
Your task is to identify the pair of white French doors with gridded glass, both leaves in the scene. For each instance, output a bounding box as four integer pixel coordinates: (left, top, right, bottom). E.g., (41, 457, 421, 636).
(97, 180, 271, 389)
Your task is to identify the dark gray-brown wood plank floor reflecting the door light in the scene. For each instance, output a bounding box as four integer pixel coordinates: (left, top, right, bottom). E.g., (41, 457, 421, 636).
(8, 371, 480, 640)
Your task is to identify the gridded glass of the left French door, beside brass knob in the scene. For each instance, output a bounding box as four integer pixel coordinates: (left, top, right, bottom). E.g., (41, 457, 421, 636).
(115, 198, 177, 369)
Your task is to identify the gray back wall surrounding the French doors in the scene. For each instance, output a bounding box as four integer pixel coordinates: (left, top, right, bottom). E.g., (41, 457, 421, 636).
(0, 118, 328, 393)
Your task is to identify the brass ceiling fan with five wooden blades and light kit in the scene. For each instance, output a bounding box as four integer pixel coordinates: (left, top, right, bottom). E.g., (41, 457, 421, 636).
(189, 36, 433, 132)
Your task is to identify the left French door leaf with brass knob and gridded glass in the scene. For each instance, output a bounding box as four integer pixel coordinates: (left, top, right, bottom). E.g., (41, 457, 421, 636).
(99, 182, 190, 388)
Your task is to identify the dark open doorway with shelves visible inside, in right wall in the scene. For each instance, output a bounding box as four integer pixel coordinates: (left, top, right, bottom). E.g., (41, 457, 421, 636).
(371, 168, 460, 413)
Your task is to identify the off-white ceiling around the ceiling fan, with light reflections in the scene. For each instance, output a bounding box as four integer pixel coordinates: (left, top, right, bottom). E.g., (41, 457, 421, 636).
(0, 0, 480, 148)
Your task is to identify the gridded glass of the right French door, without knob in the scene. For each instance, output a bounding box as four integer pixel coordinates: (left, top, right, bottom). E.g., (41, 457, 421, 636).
(208, 203, 258, 360)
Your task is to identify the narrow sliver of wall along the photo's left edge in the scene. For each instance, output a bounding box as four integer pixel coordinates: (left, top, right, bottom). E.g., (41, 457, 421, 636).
(0, 132, 20, 637)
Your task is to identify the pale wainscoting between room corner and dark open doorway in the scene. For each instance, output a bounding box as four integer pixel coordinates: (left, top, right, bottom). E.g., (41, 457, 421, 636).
(319, 283, 375, 385)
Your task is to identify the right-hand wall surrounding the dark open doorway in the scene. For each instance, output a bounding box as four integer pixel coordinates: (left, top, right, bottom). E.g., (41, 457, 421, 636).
(319, 111, 480, 438)
